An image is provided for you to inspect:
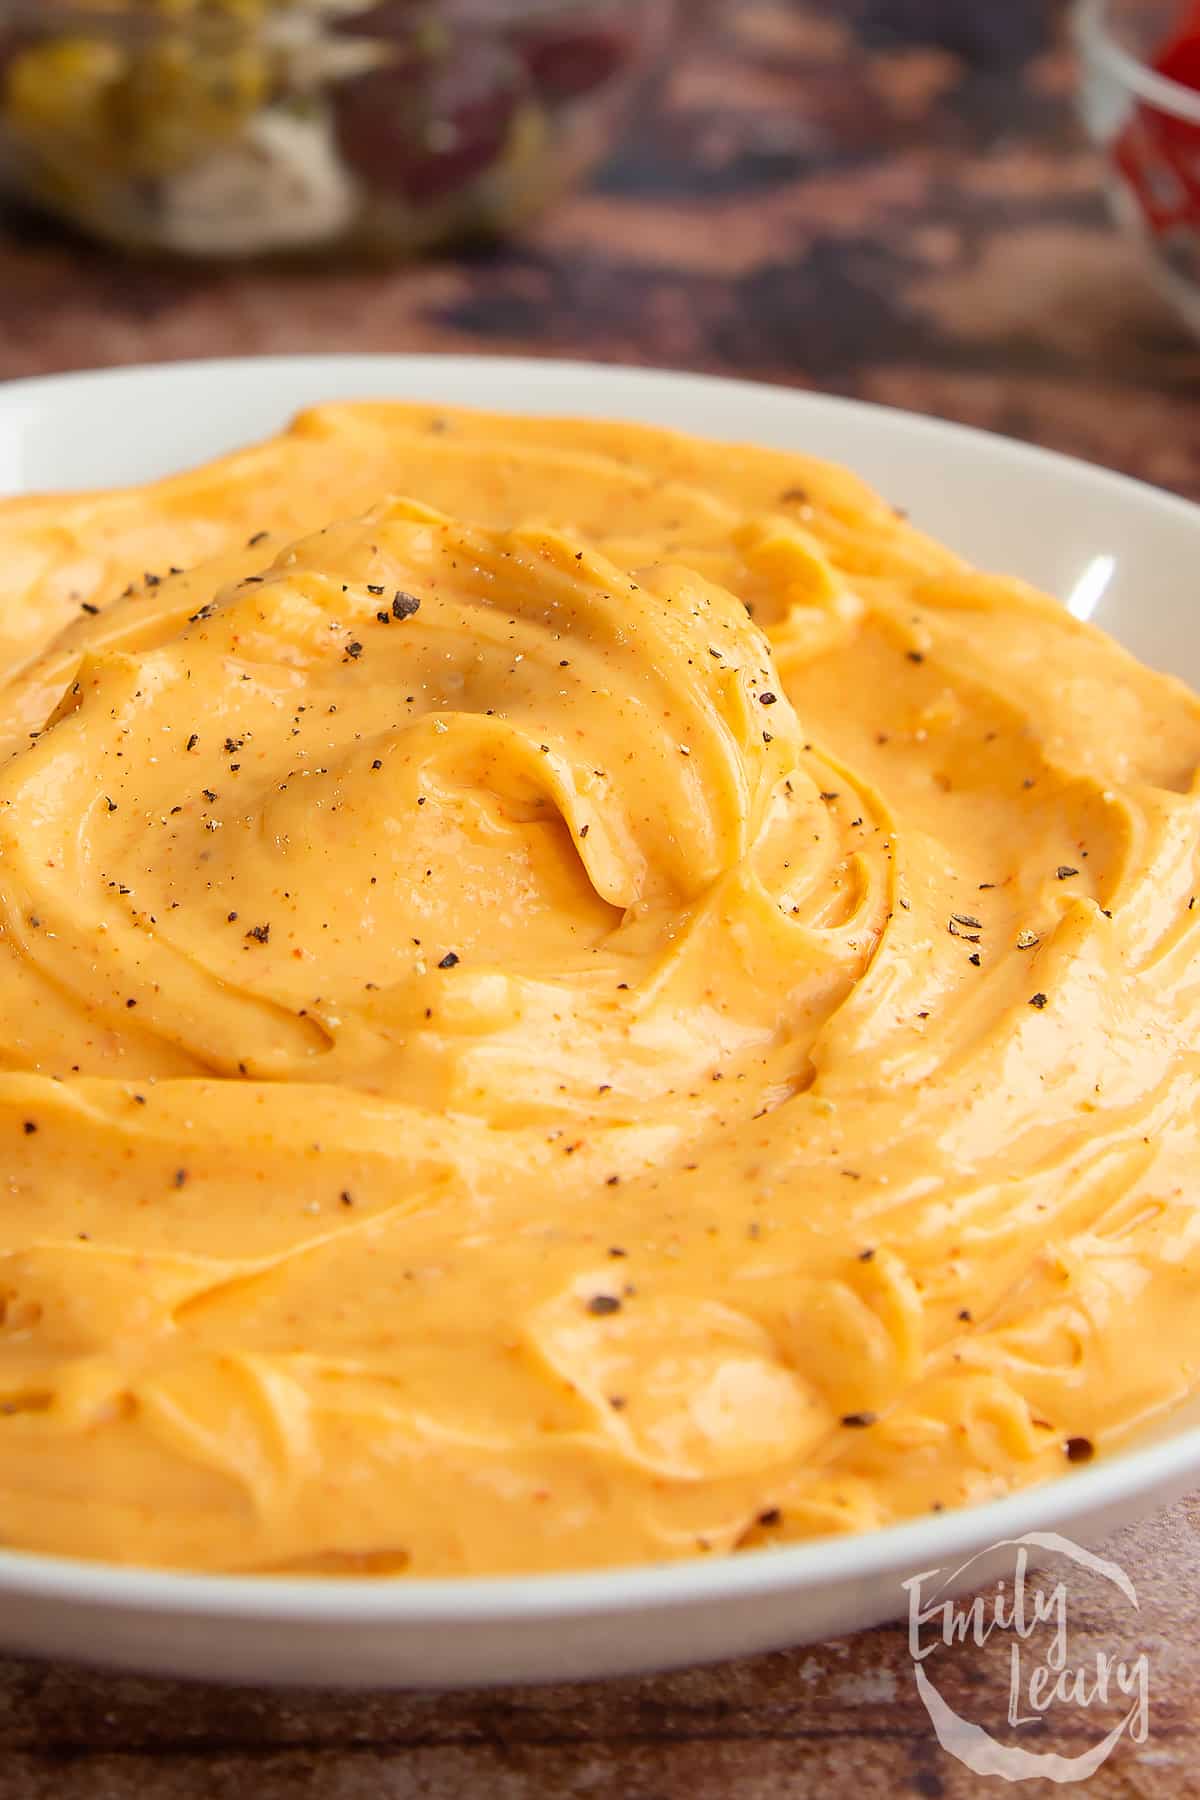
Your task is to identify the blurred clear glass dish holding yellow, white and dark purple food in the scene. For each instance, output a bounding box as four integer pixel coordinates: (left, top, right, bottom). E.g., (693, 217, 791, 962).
(0, 0, 675, 257)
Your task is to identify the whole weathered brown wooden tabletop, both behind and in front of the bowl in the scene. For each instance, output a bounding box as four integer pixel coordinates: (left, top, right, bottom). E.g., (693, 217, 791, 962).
(0, 0, 1200, 1800)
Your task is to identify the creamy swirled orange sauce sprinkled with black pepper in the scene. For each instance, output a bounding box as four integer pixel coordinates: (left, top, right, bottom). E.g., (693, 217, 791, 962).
(0, 405, 1200, 1575)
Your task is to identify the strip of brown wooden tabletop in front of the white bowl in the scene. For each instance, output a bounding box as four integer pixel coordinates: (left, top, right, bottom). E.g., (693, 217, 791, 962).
(0, 1501, 1200, 1800)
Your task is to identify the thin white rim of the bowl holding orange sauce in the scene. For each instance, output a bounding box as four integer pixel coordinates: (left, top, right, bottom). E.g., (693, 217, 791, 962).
(0, 353, 1200, 1627)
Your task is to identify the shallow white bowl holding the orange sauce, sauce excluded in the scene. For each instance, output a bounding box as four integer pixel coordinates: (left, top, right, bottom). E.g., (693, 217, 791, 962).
(0, 356, 1200, 1687)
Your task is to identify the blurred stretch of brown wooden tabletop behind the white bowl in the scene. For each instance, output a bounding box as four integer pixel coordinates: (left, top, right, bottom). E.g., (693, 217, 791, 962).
(0, 0, 1200, 495)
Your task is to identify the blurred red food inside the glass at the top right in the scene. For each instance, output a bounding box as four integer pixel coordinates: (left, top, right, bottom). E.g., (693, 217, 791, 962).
(1114, 0, 1200, 238)
